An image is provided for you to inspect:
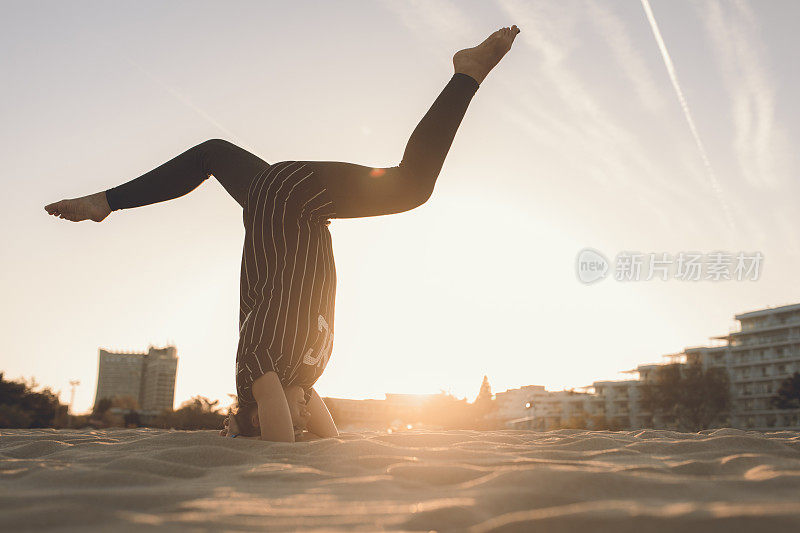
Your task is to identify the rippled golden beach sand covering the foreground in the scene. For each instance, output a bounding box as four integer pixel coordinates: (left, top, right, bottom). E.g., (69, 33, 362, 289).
(0, 429, 800, 533)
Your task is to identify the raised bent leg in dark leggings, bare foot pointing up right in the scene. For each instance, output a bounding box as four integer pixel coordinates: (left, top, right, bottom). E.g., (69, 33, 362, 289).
(305, 26, 519, 218)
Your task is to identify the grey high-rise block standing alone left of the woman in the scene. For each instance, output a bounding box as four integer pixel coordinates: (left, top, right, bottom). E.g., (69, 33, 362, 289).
(94, 346, 178, 413)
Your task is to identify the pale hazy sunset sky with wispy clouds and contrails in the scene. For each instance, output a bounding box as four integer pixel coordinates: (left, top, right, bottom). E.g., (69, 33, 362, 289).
(0, 0, 800, 412)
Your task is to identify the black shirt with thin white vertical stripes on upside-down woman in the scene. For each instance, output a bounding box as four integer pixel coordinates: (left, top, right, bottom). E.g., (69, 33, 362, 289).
(236, 161, 336, 405)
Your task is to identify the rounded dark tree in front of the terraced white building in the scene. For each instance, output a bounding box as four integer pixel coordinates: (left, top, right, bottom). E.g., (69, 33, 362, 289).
(640, 363, 730, 431)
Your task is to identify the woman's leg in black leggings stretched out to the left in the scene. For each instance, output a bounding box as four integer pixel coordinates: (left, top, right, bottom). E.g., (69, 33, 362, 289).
(45, 139, 270, 222)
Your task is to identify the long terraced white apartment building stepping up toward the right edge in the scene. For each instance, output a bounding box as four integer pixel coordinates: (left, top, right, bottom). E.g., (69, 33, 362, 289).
(496, 304, 800, 431)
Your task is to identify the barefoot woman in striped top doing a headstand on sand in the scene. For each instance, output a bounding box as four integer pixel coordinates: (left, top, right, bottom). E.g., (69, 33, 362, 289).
(45, 26, 519, 442)
